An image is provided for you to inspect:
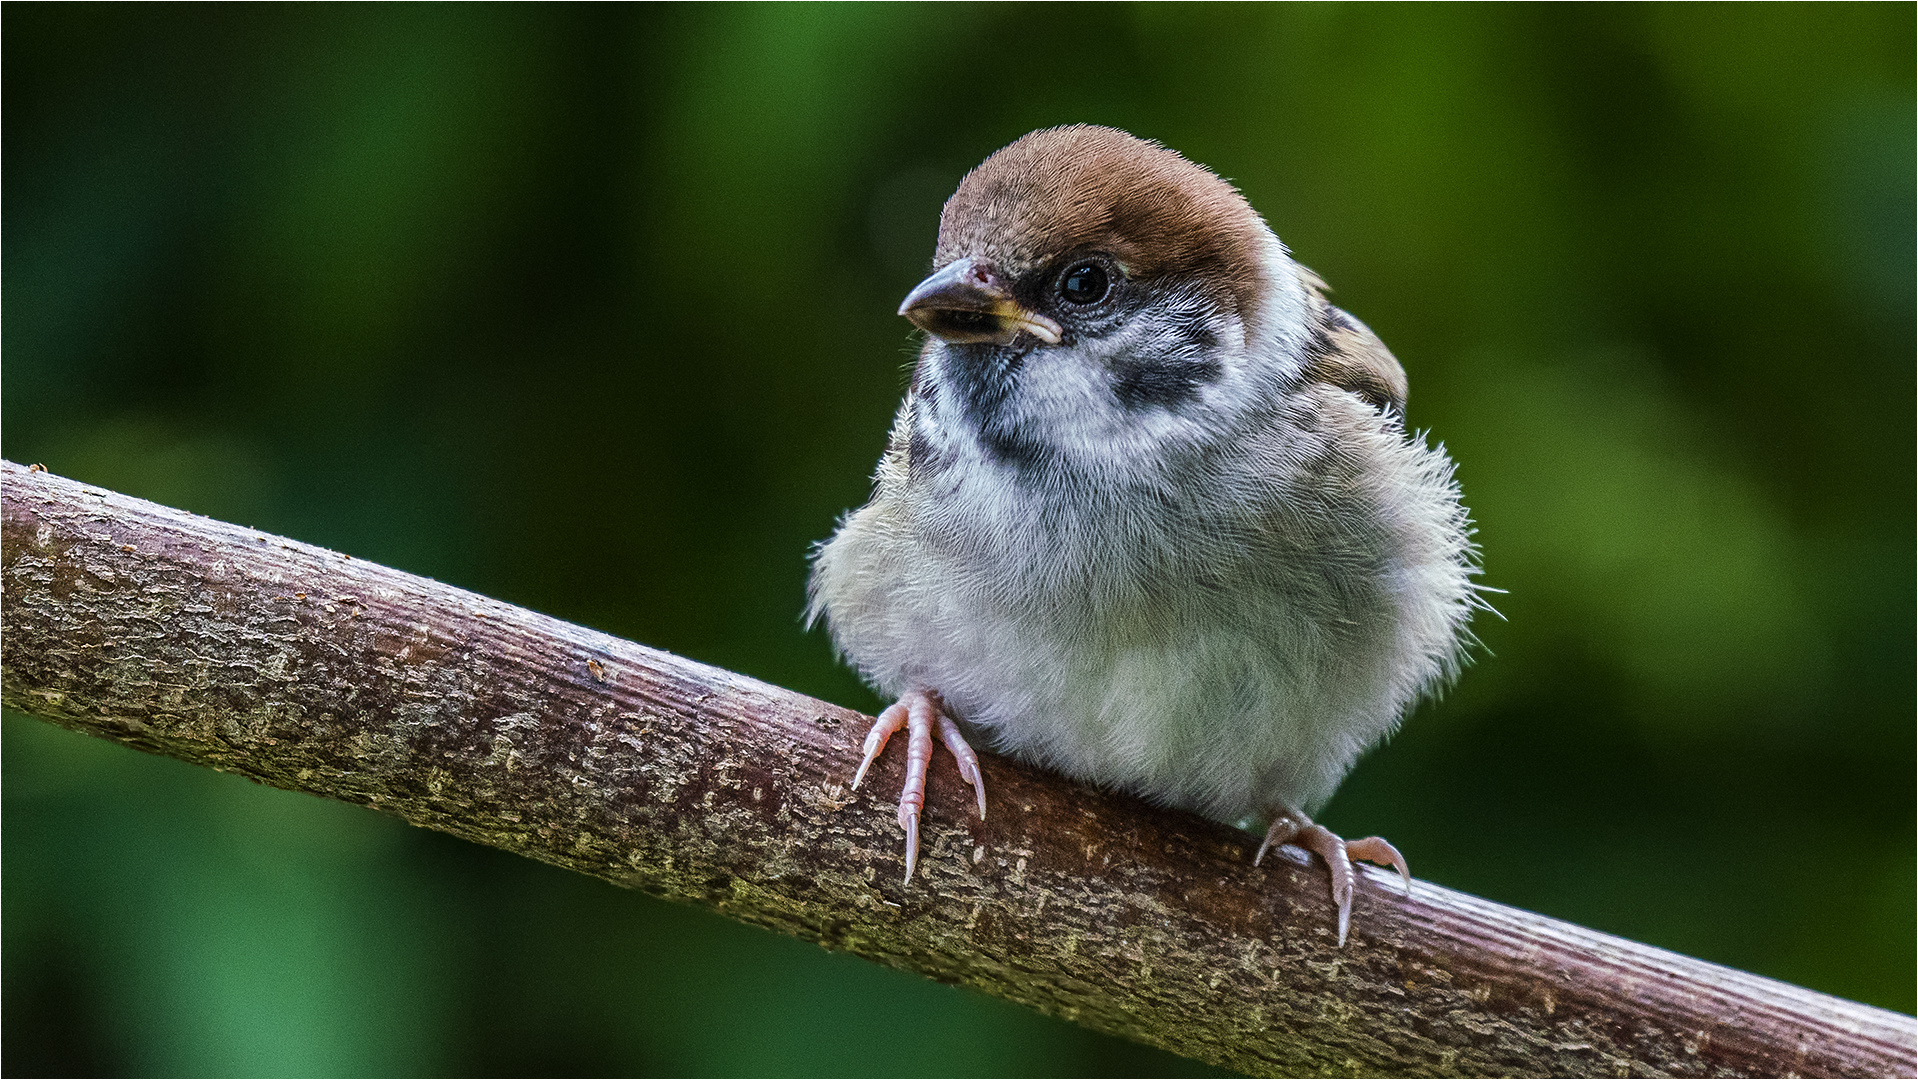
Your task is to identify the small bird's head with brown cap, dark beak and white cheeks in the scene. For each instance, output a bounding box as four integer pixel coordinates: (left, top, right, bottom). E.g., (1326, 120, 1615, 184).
(900, 125, 1306, 481)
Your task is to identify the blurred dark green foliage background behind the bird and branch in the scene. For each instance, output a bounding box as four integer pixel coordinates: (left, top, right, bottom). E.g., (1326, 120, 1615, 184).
(0, 4, 1918, 1074)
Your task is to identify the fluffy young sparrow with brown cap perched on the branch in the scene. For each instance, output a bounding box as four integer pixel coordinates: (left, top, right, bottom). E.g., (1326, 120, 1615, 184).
(806, 125, 1486, 948)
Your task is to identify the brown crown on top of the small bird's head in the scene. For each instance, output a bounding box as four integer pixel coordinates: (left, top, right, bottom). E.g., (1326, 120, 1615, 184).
(934, 125, 1264, 313)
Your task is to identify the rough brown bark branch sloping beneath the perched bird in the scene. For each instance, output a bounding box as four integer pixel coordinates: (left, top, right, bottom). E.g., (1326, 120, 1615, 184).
(0, 462, 1918, 1076)
